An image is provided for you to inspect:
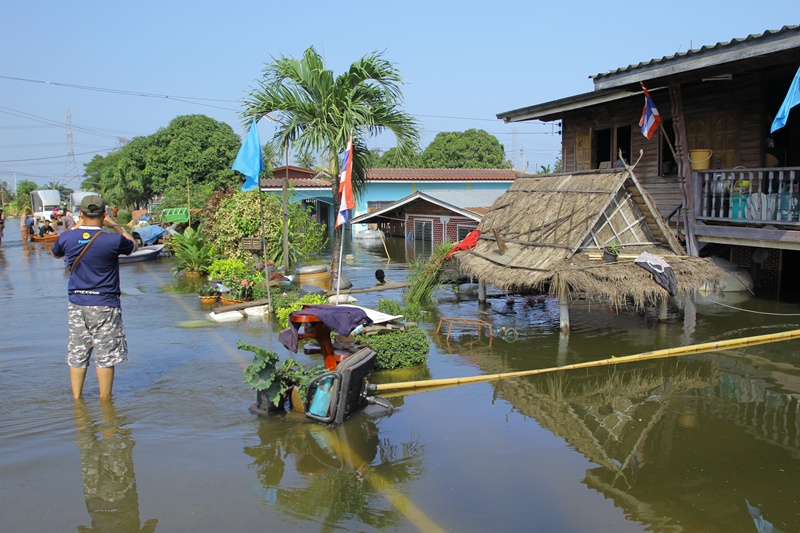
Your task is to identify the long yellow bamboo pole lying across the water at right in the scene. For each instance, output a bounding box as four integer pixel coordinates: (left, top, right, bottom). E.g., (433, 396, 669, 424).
(370, 329, 800, 392)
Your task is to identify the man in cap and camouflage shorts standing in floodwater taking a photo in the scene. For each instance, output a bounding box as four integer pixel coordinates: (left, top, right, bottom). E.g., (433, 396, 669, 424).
(51, 194, 137, 399)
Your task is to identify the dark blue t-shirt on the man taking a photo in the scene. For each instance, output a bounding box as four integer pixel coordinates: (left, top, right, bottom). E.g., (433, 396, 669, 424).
(50, 226, 134, 307)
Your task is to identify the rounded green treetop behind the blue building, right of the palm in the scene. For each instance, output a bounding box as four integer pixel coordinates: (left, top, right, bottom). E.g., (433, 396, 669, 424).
(417, 129, 511, 168)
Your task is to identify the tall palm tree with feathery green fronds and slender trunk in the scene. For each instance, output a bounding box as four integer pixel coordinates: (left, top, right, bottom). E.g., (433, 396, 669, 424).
(242, 46, 419, 280)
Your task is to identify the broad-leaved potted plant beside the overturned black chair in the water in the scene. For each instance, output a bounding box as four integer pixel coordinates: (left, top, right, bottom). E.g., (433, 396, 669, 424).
(237, 341, 325, 411)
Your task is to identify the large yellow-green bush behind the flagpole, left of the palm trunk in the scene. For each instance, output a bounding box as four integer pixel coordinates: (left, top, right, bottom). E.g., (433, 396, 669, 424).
(203, 190, 327, 264)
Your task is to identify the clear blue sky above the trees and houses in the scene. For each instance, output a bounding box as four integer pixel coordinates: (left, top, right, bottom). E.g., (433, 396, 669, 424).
(0, 0, 800, 189)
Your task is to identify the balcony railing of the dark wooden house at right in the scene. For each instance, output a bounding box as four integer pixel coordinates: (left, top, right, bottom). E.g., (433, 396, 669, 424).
(692, 167, 800, 224)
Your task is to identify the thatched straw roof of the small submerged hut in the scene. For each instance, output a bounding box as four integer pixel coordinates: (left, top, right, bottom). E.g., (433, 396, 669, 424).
(455, 169, 725, 307)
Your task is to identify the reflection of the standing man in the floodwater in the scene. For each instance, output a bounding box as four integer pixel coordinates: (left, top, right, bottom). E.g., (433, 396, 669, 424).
(75, 400, 158, 533)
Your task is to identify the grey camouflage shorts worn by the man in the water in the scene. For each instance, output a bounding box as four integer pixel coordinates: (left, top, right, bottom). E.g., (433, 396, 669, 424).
(67, 304, 128, 368)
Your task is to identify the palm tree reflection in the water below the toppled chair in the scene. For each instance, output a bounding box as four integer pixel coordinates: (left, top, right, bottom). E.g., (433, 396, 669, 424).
(244, 415, 424, 531)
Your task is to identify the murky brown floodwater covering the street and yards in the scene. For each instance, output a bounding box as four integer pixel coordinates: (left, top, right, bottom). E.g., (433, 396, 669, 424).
(0, 222, 800, 532)
